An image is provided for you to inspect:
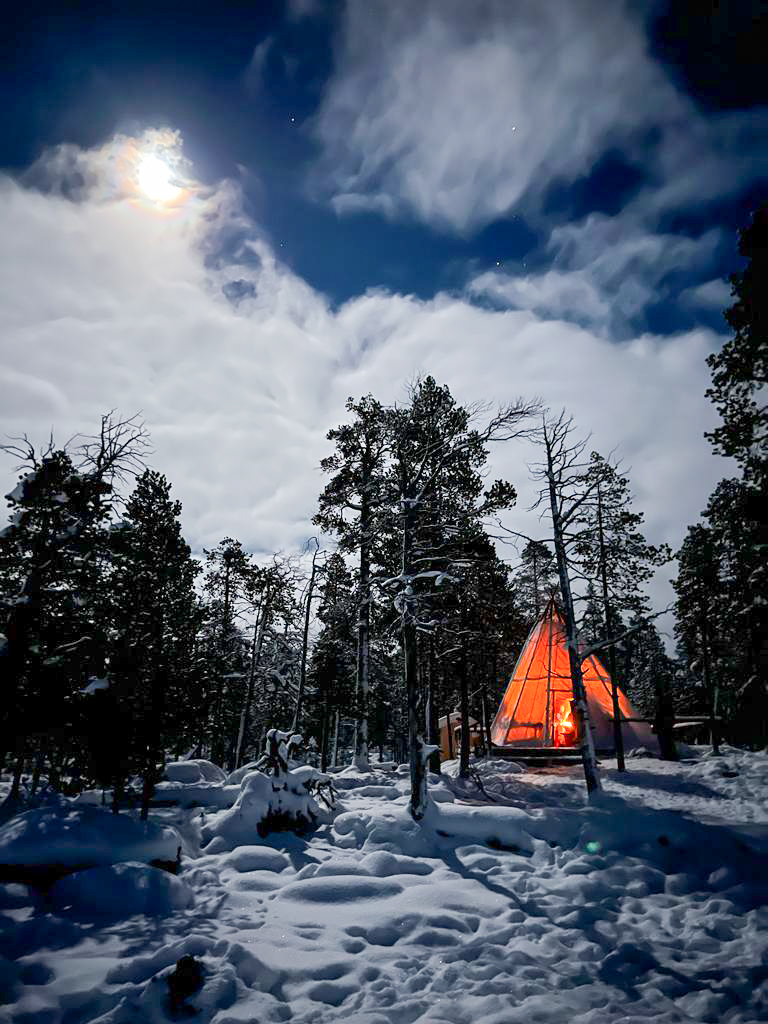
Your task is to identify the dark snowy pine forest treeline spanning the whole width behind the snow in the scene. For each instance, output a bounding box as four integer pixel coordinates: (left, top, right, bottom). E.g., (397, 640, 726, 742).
(0, 210, 768, 813)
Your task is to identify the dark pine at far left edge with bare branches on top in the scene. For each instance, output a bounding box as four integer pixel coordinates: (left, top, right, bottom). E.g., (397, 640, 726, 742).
(0, 414, 148, 801)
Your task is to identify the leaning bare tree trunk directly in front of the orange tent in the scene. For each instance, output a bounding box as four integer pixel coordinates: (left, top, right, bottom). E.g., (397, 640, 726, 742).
(545, 434, 602, 794)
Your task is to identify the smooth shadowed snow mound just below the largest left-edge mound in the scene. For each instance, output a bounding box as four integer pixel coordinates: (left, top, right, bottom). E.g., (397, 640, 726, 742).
(50, 861, 193, 918)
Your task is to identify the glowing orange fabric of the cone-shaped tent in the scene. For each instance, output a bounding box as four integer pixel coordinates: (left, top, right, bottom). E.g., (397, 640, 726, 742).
(490, 601, 658, 753)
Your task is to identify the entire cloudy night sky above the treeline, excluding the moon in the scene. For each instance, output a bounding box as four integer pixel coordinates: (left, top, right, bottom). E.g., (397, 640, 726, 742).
(0, 0, 768, 614)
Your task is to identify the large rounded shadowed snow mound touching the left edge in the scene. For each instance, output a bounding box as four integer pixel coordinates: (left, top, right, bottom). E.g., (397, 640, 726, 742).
(0, 805, 181, 866)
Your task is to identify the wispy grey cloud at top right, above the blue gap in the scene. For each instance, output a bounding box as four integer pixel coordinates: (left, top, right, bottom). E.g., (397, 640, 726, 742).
(314, 0, 768, 232)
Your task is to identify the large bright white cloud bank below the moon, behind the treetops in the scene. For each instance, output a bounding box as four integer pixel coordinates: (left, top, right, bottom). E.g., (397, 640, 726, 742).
(0, 137, 727, 630)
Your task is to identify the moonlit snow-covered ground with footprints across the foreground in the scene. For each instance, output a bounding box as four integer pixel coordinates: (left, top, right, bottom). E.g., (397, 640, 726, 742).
(0, 750, 768, 1024)
